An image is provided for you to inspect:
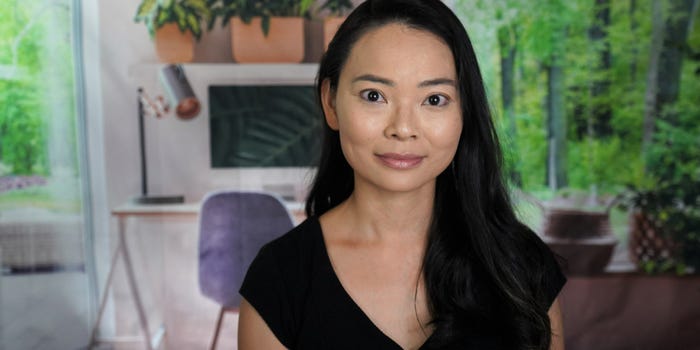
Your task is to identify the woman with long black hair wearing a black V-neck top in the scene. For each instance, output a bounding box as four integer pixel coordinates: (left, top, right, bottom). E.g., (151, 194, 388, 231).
(238, 0, 565, 350)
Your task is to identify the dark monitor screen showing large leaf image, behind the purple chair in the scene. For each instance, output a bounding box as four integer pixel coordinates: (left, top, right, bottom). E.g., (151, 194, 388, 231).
(209, 85, 322, 168)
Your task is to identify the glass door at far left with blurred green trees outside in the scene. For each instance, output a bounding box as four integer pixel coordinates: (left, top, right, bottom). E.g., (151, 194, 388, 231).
(0, 0, 94, 350)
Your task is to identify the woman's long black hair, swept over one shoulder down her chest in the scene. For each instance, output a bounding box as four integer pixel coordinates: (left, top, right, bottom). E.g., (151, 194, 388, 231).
(306, 0, 551, 349)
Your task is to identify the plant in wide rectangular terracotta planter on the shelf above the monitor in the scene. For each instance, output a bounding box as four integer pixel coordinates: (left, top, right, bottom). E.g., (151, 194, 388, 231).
(217, 0, 313, 63)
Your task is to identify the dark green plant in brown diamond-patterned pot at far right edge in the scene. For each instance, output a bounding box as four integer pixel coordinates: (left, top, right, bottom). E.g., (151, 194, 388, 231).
(622, 122, 700, 275)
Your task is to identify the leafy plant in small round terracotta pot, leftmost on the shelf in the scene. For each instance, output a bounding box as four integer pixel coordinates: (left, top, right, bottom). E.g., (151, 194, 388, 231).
(134, 0, 216, 63)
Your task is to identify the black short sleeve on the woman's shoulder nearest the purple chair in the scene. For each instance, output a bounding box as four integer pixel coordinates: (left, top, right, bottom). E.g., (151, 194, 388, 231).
(240, 245, 294, 349)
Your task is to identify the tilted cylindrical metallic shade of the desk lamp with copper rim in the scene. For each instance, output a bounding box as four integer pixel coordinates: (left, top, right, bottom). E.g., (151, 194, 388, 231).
(160, 64, 201, 119)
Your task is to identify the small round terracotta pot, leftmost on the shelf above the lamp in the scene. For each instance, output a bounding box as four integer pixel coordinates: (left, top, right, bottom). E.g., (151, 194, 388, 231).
(154, 23, 194, 63)
